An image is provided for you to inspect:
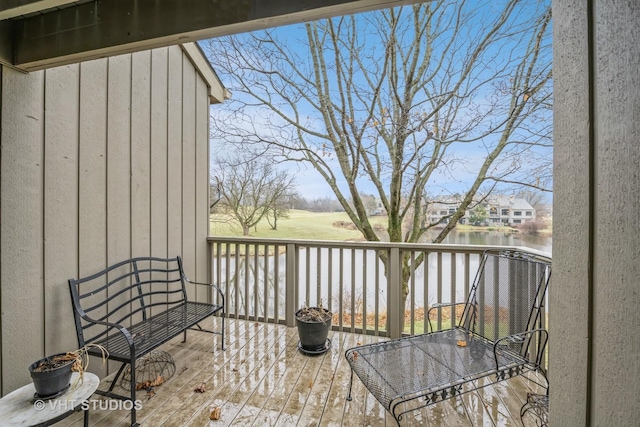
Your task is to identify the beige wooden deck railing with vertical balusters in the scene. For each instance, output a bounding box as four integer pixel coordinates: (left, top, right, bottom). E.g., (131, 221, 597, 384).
(208, 237, 548, 337)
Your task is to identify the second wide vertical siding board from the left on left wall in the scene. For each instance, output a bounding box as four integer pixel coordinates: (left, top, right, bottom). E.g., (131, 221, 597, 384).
(43, 64, 80, 361)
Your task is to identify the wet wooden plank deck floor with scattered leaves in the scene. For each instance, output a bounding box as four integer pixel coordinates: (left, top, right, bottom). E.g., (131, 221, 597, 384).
(56, 320, 540, 427)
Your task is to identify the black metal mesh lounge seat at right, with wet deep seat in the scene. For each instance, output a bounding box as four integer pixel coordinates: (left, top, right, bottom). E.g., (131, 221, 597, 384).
(345, 251, 551, 425)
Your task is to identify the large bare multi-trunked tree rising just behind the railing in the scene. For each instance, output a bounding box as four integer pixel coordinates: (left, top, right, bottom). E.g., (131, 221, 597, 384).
(205, 0, 552, 314)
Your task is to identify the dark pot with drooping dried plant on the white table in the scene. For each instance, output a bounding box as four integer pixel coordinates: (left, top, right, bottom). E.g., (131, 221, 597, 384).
(29, 344, 108, 399)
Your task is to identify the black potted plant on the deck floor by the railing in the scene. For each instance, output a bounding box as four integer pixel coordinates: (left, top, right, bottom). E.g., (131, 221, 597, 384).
(296, 306, 332, 354)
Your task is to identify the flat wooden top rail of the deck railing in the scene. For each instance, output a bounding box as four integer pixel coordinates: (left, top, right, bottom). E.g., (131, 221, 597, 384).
(207, 236, 551, 262)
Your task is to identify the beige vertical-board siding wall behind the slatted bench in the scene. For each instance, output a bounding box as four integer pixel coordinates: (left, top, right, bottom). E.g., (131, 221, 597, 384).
(0, 46, 215, 395)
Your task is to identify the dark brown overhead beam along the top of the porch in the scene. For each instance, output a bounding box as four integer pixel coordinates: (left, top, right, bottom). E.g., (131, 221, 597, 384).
(0, 0, 416, 71)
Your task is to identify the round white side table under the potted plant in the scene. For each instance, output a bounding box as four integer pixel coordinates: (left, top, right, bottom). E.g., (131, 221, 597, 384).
(0, 372, 100, 427)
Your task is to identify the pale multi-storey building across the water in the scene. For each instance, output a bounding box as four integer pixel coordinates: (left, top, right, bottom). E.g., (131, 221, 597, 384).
(427, 196, 536, 225)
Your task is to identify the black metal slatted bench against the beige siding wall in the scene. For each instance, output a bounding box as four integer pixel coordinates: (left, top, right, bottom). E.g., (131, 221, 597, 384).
(69, 257, 224, 425)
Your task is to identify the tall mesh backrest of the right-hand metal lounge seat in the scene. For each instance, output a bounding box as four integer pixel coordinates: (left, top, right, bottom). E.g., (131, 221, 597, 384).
(458, 250, 551, 360)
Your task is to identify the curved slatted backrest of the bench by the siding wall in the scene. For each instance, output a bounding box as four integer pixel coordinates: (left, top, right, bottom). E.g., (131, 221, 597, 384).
(69, 257, 187, 347)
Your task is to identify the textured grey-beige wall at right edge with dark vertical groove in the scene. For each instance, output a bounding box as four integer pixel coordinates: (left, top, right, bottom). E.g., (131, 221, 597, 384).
(549, 0, 640, 426)
